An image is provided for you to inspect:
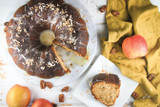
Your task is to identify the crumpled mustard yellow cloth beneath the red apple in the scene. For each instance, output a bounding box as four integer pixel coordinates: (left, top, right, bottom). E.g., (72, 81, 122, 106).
(101, 0, 160, 107)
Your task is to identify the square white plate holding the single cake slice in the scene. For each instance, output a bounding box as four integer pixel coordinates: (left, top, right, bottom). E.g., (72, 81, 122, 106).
(72, 55, 138, 107)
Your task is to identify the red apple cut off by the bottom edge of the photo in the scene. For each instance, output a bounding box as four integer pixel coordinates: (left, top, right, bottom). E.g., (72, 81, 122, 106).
(31, 98, 53, 107)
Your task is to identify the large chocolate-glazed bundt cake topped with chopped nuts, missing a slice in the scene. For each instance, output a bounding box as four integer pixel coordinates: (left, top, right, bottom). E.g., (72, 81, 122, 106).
(5, 0, 89, 78)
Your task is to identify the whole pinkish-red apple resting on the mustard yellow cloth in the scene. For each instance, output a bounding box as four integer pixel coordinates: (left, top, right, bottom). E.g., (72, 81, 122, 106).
(122, 35, 148, 59)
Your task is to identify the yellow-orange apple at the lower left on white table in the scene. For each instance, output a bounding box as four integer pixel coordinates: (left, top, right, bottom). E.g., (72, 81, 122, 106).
(6, 84, 31, 107)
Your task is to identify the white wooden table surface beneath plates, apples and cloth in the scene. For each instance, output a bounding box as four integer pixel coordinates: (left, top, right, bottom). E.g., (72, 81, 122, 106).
(0, 0, 160, 107)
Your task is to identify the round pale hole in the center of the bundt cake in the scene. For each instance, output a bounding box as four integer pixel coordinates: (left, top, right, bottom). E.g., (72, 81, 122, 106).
(40, 30, 55, 46)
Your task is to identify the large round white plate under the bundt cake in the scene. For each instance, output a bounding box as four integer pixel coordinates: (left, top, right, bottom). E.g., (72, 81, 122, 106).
(0, 0, 97, 86)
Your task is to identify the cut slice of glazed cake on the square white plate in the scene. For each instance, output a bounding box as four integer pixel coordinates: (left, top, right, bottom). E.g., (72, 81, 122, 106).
(91, 73, 121, 106)
